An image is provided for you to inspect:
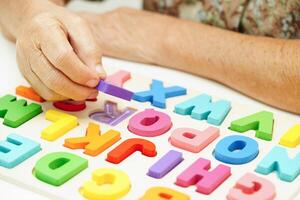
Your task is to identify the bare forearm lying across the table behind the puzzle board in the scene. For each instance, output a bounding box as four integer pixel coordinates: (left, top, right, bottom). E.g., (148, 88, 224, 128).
(82, 8, 300, 114)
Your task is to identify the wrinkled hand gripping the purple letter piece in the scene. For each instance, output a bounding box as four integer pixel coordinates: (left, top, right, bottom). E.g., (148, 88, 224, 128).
(17, 1, 105, 101)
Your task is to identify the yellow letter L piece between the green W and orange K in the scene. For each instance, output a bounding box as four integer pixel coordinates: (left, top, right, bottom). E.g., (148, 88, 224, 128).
(41, 110, 78, 141)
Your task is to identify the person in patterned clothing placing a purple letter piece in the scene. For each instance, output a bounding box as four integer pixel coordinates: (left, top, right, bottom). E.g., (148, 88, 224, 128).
(0, 0, 300, 113)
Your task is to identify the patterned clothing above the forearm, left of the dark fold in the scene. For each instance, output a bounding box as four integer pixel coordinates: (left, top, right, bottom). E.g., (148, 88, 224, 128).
(144, 0, 247, 31)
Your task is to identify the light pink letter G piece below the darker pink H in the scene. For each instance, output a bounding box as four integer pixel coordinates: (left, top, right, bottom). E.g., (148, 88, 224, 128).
(227, 173, 276, 200)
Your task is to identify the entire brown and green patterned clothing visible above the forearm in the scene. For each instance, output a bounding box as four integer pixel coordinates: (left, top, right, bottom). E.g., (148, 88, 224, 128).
(144, 0, 300, 38)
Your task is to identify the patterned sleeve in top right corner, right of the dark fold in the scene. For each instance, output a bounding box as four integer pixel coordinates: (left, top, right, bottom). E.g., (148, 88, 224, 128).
(242, 0, 300, 39)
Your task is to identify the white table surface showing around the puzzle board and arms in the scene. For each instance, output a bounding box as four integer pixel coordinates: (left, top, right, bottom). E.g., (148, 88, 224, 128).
(0, 0, 300, 199)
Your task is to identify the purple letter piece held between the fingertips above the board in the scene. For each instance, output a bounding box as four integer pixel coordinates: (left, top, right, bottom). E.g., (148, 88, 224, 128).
(97, 80, 133, 101)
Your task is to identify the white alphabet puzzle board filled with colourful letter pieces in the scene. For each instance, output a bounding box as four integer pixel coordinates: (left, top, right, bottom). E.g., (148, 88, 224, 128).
(0, 67, 300, 200)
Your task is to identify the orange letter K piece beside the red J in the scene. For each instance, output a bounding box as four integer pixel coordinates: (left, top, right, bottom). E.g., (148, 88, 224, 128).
(64, 123, 121, 156)
